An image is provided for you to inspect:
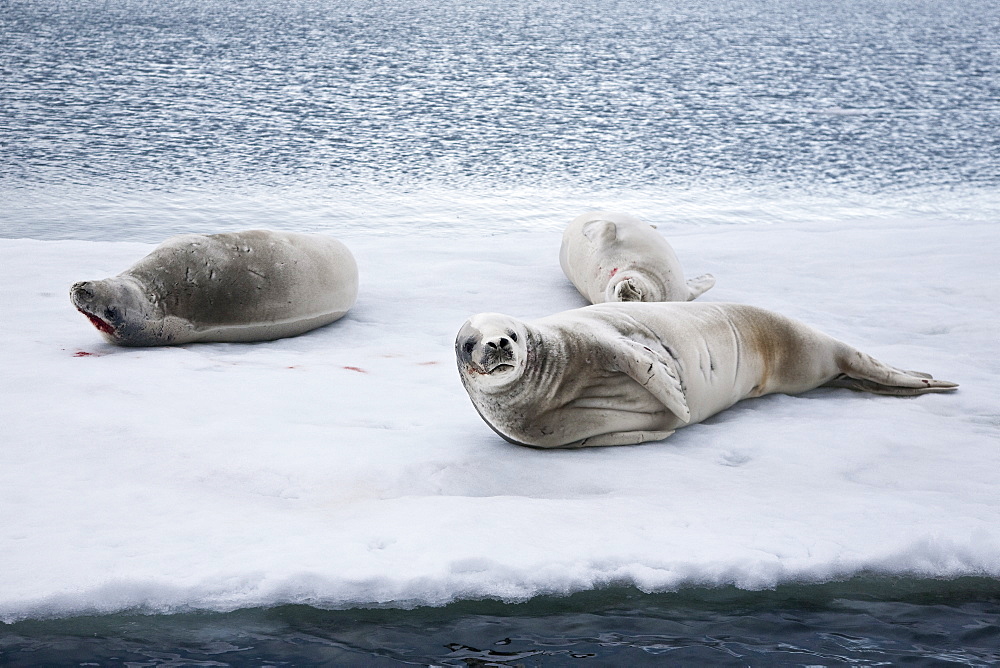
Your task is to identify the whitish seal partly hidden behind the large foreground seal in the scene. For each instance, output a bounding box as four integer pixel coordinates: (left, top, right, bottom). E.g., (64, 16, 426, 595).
(559, 211, 715, 304)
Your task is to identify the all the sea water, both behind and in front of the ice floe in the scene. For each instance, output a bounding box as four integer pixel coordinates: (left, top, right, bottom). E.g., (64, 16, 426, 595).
(0, 0, 1000, 666)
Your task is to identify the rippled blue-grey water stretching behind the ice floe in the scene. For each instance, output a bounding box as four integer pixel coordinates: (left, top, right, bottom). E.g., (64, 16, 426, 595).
(0, 0, 1000, 240)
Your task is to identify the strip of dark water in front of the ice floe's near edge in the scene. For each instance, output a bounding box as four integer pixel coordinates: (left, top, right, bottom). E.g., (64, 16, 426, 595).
(0, 578, 1000, 668)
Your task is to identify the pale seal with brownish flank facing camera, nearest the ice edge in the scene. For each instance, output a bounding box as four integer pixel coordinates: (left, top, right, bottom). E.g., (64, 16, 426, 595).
(455, 303, 958, 448)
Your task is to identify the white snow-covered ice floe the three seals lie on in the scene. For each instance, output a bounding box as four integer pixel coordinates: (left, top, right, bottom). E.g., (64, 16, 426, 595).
(0, 219, 1000, 622)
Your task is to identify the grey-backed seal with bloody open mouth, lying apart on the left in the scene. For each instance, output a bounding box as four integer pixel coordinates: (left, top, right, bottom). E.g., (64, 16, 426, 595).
(70, 230, 358, 346)
